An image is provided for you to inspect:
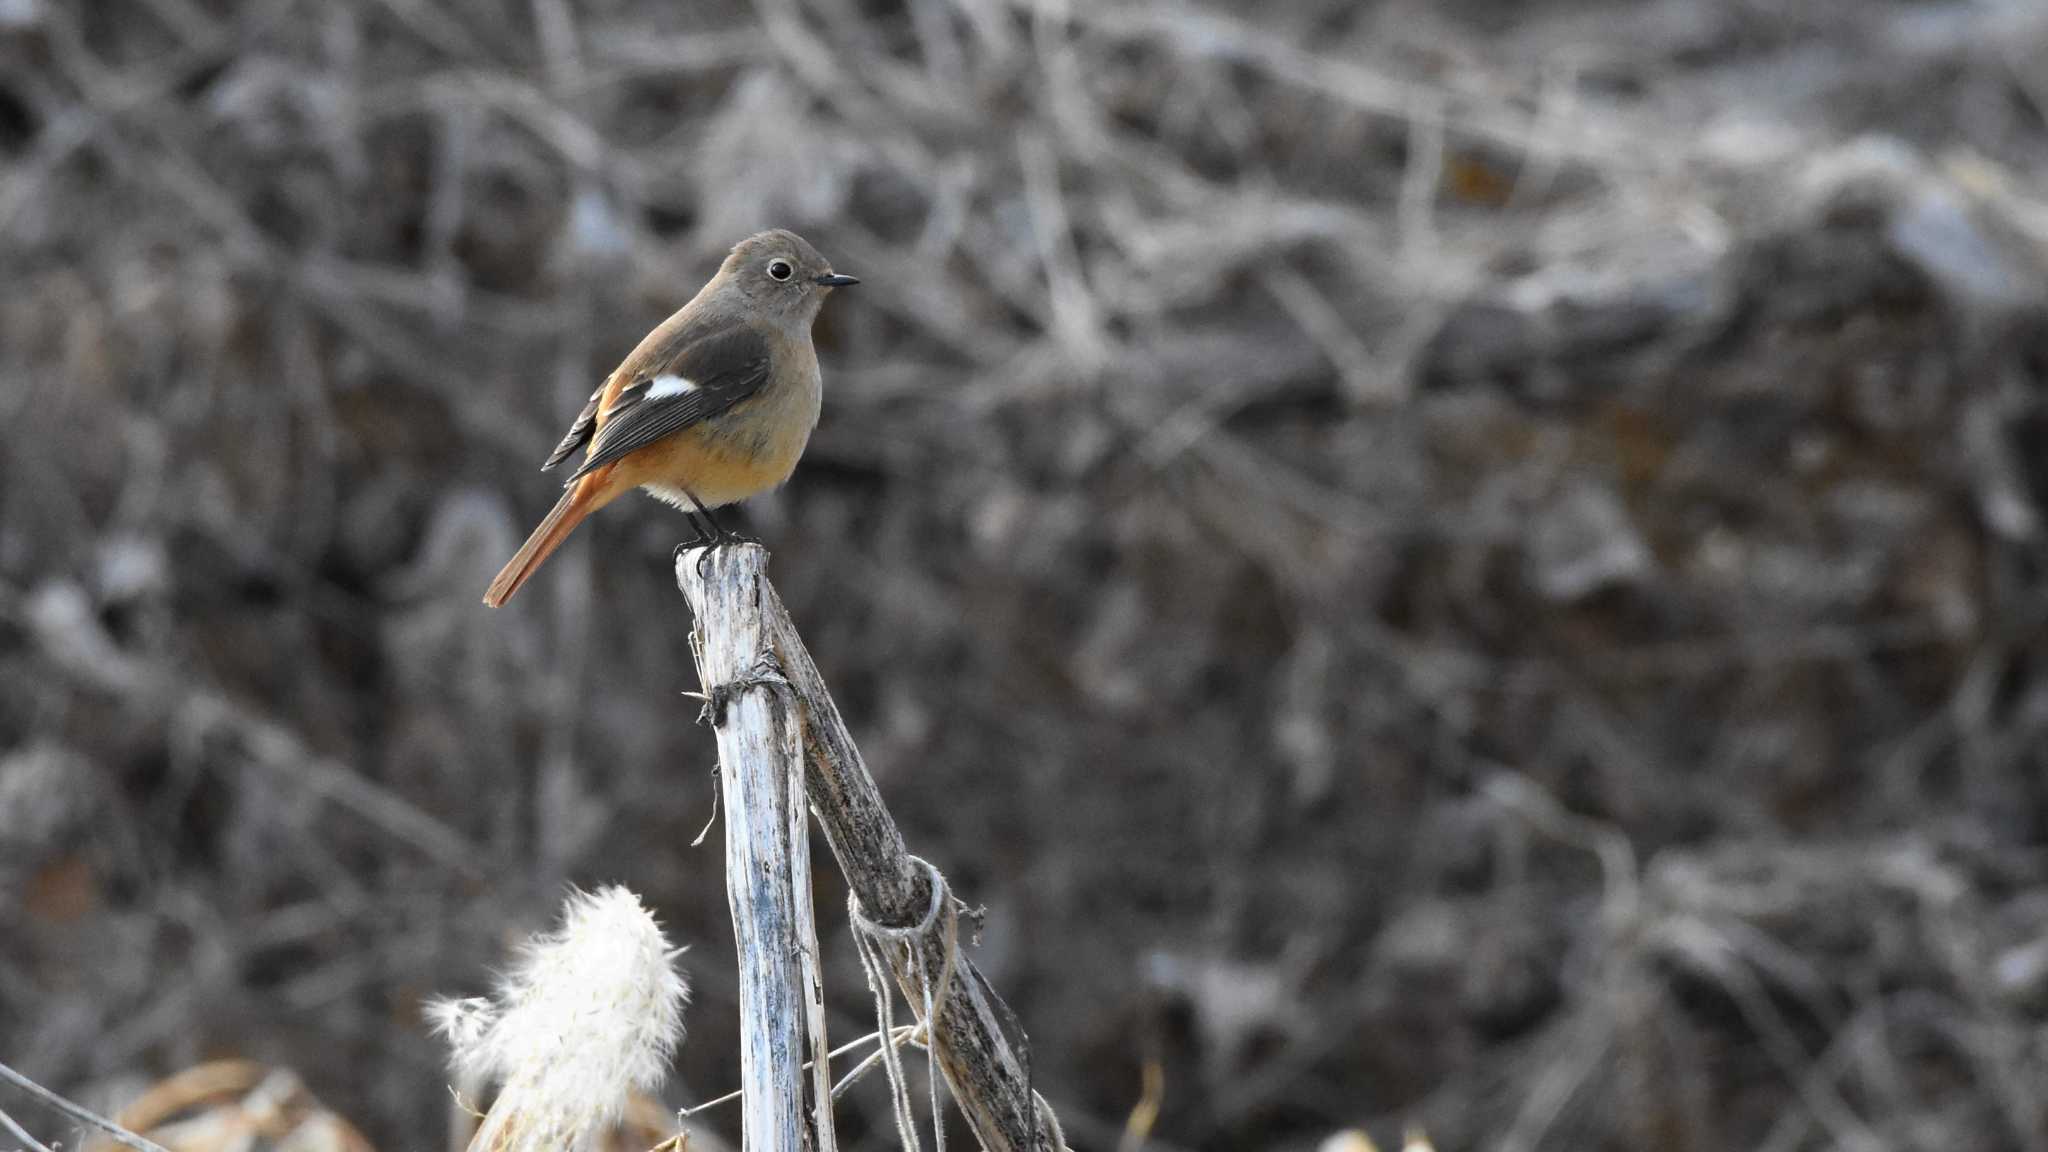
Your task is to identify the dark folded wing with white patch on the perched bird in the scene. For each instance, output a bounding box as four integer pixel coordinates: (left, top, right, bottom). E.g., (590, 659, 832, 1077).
(569, 324, 770, 482)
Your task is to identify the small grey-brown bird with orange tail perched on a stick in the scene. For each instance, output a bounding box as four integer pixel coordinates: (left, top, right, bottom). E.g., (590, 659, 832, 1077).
(483, 228, 860, 607)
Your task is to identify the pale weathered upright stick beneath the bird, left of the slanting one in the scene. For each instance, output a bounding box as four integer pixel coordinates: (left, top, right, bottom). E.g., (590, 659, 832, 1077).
(678, 549, 811, 1152)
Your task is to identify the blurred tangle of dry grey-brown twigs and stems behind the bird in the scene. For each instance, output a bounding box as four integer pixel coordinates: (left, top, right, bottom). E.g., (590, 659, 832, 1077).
(12, 0, 2048, 1152)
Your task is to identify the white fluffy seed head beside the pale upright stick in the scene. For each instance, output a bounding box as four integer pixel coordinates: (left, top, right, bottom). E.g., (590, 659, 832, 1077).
(428, 888, 688, 1152)
